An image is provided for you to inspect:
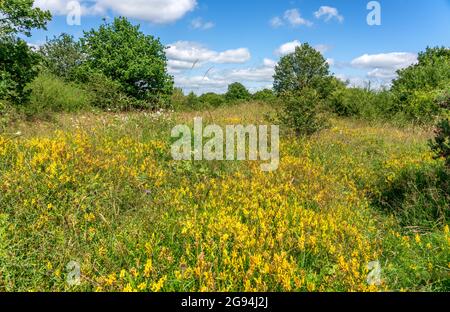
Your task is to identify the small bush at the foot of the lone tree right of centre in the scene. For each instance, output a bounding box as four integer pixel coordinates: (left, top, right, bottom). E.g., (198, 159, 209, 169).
(278, 88, 327, 136)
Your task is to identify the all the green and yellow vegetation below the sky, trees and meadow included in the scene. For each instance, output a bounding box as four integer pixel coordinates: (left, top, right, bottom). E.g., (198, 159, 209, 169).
(0, 0, 450, 291)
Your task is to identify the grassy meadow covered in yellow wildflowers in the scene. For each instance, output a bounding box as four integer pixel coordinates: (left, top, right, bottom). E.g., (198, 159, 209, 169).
(0, 103, 450, 291)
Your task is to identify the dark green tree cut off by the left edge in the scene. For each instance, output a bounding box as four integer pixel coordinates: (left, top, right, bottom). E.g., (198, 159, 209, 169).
(0, 0, 51, 103)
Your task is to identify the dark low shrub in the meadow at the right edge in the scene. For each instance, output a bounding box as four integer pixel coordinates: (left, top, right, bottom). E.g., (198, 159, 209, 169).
(375, 165, 450, 228)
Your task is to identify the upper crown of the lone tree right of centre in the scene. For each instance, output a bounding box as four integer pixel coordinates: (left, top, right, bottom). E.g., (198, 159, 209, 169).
(273, 43, 334, 99)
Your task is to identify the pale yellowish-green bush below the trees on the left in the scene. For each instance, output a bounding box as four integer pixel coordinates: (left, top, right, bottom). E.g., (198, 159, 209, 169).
(22, 72, 91, 116)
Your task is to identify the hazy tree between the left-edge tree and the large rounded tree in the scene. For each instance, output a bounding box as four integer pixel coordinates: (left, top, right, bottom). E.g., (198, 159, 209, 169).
(39, 34, 85, 80)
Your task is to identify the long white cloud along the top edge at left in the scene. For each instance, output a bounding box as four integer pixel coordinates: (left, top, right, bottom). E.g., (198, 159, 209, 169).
(34, 0, 197, 24)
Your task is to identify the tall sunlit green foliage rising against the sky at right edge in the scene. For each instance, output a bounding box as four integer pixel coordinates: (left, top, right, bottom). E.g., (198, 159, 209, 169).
(392, 47, 450, 122)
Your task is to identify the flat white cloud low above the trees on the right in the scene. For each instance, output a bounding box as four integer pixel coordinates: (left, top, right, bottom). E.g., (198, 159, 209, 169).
(351, 52, 417, 70)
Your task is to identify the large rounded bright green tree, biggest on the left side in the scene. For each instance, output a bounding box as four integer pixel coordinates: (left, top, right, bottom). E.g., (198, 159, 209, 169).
(81, 17, 173, 106)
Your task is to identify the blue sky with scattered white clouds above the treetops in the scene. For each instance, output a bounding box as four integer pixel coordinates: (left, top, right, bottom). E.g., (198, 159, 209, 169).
(28, 0, 450, 93)
